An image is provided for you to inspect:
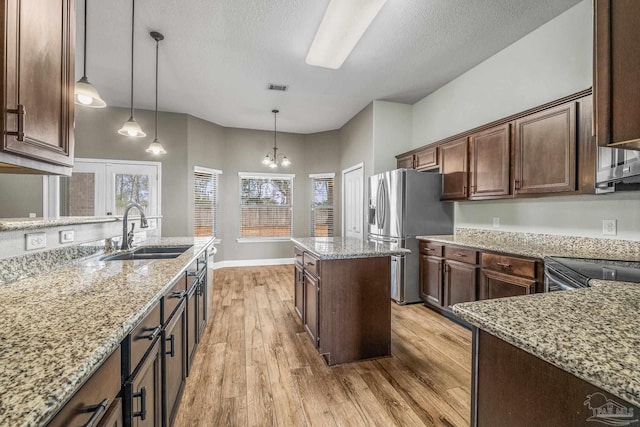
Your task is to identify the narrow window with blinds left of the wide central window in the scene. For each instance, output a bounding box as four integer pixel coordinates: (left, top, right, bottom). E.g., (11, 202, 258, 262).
(193, 166, 222, 237)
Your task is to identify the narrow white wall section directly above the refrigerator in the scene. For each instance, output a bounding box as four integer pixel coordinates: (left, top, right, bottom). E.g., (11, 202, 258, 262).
(373, 100, 413, 174)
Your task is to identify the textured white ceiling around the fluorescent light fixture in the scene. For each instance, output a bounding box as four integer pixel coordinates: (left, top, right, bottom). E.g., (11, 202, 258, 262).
(76, 0, 580, 134)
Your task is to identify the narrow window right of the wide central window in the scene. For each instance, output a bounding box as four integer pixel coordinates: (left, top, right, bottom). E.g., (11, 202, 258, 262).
(309, 173, 335, 237)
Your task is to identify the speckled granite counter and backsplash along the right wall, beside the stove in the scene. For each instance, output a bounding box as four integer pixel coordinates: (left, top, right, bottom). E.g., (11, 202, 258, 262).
(418, 228, 640, 261)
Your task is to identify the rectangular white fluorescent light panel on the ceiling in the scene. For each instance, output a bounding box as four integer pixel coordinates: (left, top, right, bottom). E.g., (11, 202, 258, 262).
(305, 0, 387, 70)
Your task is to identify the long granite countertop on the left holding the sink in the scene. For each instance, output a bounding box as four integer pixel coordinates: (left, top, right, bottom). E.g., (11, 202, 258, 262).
(0, 237, 213, 426)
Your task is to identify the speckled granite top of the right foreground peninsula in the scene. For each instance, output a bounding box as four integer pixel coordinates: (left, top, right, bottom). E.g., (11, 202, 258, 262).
(453, 280, 640, 405)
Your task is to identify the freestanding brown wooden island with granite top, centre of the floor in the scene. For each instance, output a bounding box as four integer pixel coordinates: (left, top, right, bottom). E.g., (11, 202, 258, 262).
(292, 237, 410, 365)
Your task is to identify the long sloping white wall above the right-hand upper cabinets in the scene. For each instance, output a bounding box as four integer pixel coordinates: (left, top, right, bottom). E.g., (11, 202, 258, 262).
(412, 0, 593, 148)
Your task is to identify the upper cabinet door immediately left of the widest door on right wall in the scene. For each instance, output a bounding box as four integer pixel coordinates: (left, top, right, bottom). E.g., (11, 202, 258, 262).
(469, 123, 511, 198)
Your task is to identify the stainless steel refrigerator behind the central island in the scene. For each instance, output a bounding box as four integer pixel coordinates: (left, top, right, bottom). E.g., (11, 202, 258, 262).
(368, 169, 453, 304)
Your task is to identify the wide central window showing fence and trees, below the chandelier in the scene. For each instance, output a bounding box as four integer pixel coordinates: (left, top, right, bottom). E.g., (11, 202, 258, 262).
(238, 172, 295, 240)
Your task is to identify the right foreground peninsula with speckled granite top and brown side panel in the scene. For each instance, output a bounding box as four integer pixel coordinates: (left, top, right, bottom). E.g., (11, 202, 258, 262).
(453, 280, 640, 427)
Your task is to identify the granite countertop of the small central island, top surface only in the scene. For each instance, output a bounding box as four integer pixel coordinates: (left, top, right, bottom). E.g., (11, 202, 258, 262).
(291, 237, 411, 259)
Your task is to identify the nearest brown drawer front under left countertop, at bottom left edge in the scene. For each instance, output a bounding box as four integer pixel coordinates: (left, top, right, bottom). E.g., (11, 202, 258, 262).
(48, 347, 120, 427)
